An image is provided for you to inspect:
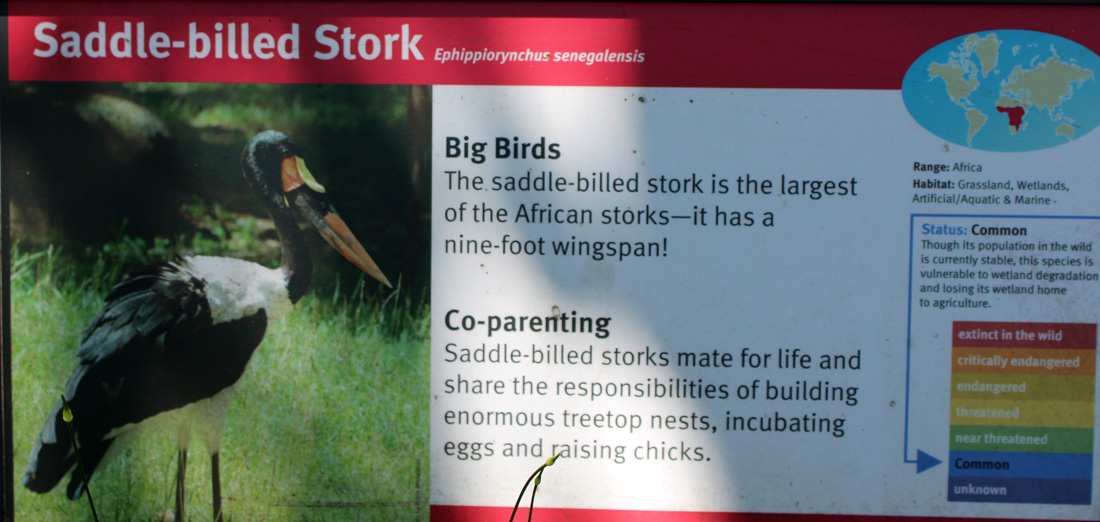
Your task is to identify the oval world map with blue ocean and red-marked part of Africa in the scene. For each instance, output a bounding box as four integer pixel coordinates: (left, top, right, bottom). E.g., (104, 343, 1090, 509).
(901, 30, 1100, 152)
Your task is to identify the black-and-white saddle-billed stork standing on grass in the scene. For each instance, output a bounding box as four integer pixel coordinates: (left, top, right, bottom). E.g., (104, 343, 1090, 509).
(23, 131, 389, 522)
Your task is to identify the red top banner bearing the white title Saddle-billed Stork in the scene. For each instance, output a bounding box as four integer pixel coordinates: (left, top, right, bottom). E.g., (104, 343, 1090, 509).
(9, 2, 1100, 89)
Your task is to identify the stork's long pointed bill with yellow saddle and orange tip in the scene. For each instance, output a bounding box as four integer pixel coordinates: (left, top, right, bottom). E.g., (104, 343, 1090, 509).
(283, 156, 393, 288)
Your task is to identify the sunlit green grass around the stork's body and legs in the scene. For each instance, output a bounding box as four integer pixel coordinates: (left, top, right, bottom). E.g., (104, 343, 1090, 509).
(10, 241, 429, 522)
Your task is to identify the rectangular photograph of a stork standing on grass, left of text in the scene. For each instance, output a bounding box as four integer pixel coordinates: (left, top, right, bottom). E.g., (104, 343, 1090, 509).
(2, 84, 431, 521)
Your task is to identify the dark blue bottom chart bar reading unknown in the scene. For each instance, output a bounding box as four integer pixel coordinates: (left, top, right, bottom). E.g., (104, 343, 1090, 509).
(947, 476, 1092, 504)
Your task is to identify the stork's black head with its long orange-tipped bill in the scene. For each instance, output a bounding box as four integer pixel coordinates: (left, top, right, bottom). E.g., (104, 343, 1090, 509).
(241, 131, 391, 287)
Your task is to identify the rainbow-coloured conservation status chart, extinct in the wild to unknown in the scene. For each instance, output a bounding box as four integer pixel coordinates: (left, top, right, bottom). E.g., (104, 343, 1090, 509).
(947, 321, 1097, 504)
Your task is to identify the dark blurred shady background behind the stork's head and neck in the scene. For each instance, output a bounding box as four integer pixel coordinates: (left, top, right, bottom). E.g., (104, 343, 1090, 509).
(3, 84, 430, 300)
